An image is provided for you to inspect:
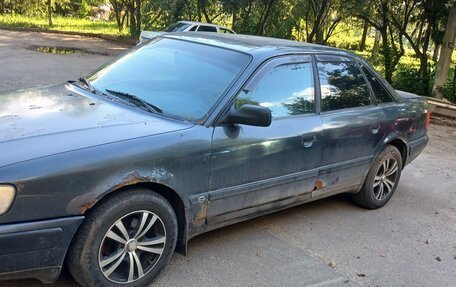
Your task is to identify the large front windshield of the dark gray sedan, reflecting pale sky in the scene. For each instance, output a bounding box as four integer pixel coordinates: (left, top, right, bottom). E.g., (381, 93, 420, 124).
(88, 38, 250, 121)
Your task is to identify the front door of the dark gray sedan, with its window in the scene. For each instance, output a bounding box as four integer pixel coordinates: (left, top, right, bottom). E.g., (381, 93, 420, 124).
(207, 56, 322, 224)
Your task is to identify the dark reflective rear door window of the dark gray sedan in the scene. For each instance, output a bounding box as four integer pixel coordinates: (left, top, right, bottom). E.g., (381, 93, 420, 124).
(318, 62, 370, 111)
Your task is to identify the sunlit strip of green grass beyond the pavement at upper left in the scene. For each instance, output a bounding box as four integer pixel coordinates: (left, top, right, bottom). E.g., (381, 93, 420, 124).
(0, 14, 128, 36)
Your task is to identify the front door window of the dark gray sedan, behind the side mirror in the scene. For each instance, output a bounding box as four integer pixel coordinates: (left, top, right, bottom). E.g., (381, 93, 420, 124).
(236, 62, 314, 118)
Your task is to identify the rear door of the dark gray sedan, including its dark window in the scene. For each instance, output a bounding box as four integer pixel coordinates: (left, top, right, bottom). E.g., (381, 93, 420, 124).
(316, 55, 385, 191)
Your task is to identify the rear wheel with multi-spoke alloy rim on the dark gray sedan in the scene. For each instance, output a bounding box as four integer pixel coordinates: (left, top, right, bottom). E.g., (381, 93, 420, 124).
(353, 145, 402, 209)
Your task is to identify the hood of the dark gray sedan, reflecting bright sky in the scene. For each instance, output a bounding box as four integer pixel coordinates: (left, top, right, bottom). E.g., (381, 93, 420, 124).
(0, 85, 193, 166)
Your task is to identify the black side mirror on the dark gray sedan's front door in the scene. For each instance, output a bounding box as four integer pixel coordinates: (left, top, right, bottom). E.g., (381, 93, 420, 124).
(223, 104, 272, 127)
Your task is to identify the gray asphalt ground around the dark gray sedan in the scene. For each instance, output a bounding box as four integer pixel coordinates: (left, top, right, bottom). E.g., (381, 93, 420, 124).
(0, 30, 456, 287)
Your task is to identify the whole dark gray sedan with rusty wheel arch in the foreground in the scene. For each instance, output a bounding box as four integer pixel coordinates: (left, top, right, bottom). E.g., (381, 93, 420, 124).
(0, 33, 429, 286)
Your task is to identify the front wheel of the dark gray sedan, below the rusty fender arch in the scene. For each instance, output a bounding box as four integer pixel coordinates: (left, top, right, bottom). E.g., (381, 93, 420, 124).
(67, 189, 178, 287)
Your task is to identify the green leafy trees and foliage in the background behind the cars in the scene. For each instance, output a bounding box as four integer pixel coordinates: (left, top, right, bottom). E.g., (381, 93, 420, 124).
(0, 0, 456, 102)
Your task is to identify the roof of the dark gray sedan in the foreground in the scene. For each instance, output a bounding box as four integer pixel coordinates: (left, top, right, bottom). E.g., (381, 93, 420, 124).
(161, 32, 359, 58)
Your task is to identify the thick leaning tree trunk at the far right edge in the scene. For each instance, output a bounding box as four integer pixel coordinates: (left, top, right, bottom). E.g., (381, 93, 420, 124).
(432, 7, 456, 99)
